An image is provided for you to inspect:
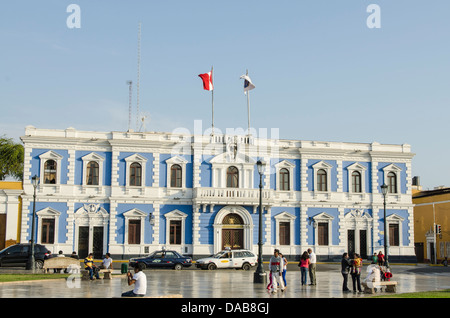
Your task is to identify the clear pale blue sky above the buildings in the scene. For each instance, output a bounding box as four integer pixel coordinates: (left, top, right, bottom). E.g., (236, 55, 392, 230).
(0, 0, 450, 189)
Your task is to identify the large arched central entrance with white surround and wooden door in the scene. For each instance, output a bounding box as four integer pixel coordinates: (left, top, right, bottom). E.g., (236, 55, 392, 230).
(213, 206, 253, 253)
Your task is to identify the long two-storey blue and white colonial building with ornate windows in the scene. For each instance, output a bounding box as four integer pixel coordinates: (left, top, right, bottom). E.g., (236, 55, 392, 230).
(21, 126, 415, 261)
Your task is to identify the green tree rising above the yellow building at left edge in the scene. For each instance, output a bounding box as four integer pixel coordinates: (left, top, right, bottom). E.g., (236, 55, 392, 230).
(0, 136, 24, 181)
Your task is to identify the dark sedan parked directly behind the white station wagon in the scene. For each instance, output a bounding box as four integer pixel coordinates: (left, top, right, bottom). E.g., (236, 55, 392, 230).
(129, 250, 192, 270)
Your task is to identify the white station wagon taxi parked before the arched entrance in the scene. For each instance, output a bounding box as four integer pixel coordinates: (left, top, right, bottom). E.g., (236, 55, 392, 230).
(195, 250, 258, 270)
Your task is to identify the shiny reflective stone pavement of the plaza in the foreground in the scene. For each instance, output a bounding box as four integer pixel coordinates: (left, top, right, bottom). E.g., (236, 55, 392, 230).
(0, 264, 450, 300)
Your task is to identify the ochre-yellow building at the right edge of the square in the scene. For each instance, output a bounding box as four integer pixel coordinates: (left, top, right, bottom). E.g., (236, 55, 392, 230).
(412, 188, 450, 264)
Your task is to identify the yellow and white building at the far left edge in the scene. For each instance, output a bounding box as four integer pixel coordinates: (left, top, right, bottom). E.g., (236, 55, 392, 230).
(0, 181, 23, 249)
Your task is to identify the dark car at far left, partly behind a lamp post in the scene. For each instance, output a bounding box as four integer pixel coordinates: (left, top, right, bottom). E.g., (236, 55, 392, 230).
(0, 244, 48, 268)
